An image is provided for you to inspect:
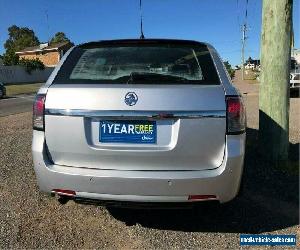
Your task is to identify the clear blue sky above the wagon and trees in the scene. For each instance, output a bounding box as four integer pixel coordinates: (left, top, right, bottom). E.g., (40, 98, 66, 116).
(0, 0, 300, 65)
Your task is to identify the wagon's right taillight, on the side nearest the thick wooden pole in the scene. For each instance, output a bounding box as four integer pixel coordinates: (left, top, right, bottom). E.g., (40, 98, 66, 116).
(226, 96, 246, 134)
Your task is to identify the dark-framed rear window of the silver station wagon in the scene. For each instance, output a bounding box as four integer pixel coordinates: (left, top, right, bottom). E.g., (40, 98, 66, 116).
(54, 40, 219, 85)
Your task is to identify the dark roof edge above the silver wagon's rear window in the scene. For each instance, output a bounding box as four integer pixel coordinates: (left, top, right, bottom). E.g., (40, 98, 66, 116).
(77, 38, 209, 48)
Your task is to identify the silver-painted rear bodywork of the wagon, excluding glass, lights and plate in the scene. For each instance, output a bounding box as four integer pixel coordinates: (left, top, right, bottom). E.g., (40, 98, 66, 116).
(32, 40, 245, 202)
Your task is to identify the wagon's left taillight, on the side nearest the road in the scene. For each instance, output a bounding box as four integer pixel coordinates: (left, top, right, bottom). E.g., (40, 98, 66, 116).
(32, 94, 46, 130)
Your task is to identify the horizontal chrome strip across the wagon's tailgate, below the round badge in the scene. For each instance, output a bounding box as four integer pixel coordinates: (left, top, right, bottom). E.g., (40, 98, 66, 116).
(45, 109, 226, 119)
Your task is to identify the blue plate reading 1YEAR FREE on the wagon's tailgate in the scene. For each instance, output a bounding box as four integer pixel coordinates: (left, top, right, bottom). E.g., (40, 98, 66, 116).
(99, 121, 157, 144)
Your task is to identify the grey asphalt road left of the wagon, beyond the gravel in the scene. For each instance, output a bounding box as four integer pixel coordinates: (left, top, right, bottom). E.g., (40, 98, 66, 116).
(0, 95, 35, 116)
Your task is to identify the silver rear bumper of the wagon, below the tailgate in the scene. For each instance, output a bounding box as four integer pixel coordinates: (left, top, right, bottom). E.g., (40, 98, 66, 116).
(32, 131, 245, 203)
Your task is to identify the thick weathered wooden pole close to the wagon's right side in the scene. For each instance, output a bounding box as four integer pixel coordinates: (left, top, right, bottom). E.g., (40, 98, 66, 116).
(259, 0, 293, 165)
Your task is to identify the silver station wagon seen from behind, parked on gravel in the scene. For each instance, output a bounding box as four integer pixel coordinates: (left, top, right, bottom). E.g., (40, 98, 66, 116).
(32, 39, 246, 206)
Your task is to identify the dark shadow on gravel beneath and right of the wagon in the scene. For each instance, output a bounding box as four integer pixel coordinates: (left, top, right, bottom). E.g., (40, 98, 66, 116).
(108, 129, 299, 233)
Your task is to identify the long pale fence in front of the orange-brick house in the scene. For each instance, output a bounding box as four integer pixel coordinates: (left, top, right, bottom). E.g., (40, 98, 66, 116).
(0, 66, 54, 84)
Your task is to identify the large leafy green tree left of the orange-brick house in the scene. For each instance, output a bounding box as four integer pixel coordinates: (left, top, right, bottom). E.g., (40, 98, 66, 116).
(3, 25, 39, 65)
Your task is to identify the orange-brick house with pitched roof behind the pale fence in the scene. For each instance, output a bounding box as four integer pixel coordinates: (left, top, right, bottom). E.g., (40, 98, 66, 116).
(16, 42, 73, 67)
